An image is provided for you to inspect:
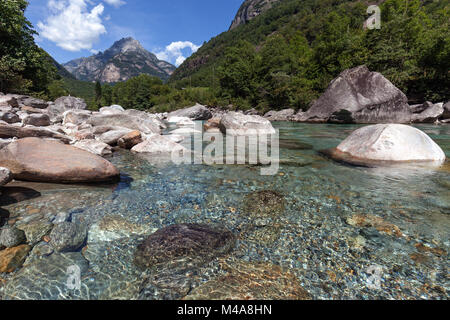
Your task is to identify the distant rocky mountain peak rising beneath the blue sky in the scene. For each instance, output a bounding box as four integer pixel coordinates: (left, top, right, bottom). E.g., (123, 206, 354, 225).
(63, 38, 176, 83)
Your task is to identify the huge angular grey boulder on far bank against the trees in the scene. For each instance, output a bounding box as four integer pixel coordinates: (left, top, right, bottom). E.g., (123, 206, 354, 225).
(296, 66, 411, 123)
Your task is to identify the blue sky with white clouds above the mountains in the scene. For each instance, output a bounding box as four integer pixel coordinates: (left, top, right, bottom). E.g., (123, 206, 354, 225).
(25, 0, 243, 65)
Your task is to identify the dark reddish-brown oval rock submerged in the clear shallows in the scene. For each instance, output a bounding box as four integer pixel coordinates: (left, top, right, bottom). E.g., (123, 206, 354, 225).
(134, 224, 235, 269)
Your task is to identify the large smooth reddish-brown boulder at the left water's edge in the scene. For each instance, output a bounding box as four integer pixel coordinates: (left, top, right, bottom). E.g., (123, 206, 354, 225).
(0, 138, 119, 183)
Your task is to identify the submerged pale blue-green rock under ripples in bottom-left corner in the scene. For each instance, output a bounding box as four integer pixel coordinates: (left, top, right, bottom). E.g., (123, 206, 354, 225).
(3, 252, 90, 300)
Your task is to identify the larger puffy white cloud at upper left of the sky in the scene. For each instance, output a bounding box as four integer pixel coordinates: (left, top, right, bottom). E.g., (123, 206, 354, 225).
(37, 0, 106, 51)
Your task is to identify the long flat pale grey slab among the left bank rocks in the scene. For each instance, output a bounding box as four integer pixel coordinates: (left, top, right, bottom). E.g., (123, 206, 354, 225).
(87, 113, 161, 134)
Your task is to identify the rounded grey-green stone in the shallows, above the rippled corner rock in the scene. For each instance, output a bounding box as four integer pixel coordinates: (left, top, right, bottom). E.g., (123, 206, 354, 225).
(50, 222, 87, 252)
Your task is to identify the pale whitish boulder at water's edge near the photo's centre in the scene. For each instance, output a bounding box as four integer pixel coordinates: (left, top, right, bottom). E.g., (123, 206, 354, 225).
(219, 112, 276, 136)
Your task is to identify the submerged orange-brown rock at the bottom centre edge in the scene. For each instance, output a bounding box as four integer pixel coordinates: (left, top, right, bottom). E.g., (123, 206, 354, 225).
(184, 261, 312, 301)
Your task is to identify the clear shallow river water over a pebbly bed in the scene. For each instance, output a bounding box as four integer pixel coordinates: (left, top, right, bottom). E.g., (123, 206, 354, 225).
(0, 122, 450, 299)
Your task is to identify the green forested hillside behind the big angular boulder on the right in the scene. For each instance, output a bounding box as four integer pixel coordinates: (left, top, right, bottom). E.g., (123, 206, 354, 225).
(171, 0, 450, 110)
